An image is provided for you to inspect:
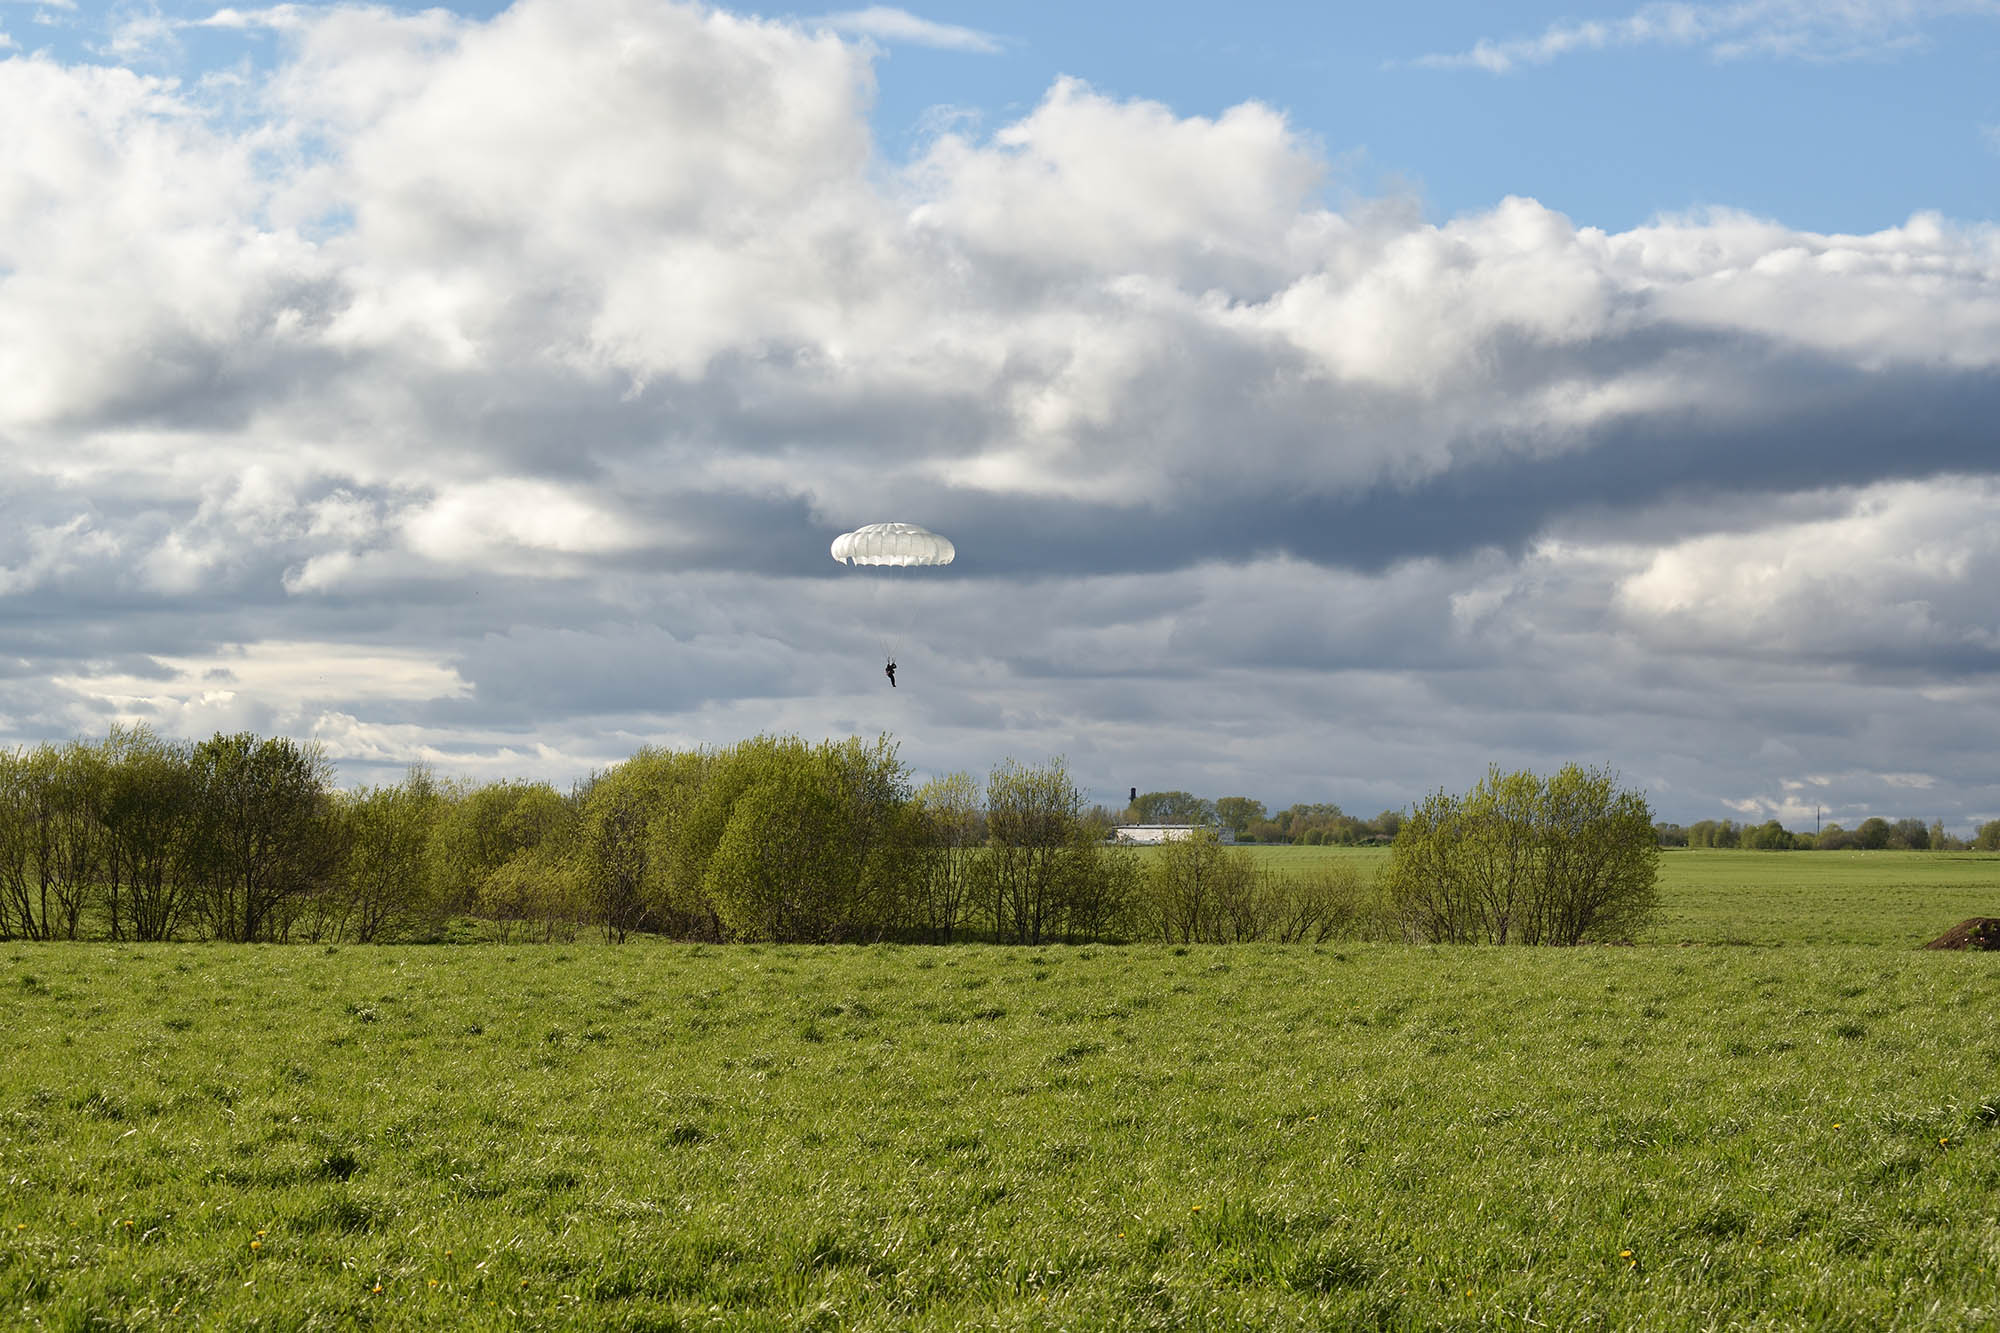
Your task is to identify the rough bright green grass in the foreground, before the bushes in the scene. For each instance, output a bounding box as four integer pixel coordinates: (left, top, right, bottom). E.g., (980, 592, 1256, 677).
(0, 945, 2000, 1329)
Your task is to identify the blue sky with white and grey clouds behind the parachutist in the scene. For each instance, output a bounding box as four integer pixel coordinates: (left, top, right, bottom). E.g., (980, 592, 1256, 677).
(0, 0, 2000, 827)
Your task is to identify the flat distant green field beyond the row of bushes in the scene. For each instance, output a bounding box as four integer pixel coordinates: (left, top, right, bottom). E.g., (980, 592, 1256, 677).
(1216, 847, 2000, 949)
